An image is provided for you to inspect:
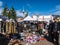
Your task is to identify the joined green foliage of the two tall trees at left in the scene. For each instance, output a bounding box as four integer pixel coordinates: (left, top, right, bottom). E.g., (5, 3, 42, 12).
(2, 6, 16, 20)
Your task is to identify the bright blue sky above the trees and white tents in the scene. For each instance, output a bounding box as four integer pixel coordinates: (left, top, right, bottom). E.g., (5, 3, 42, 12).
(0, 0, 60, 15)
